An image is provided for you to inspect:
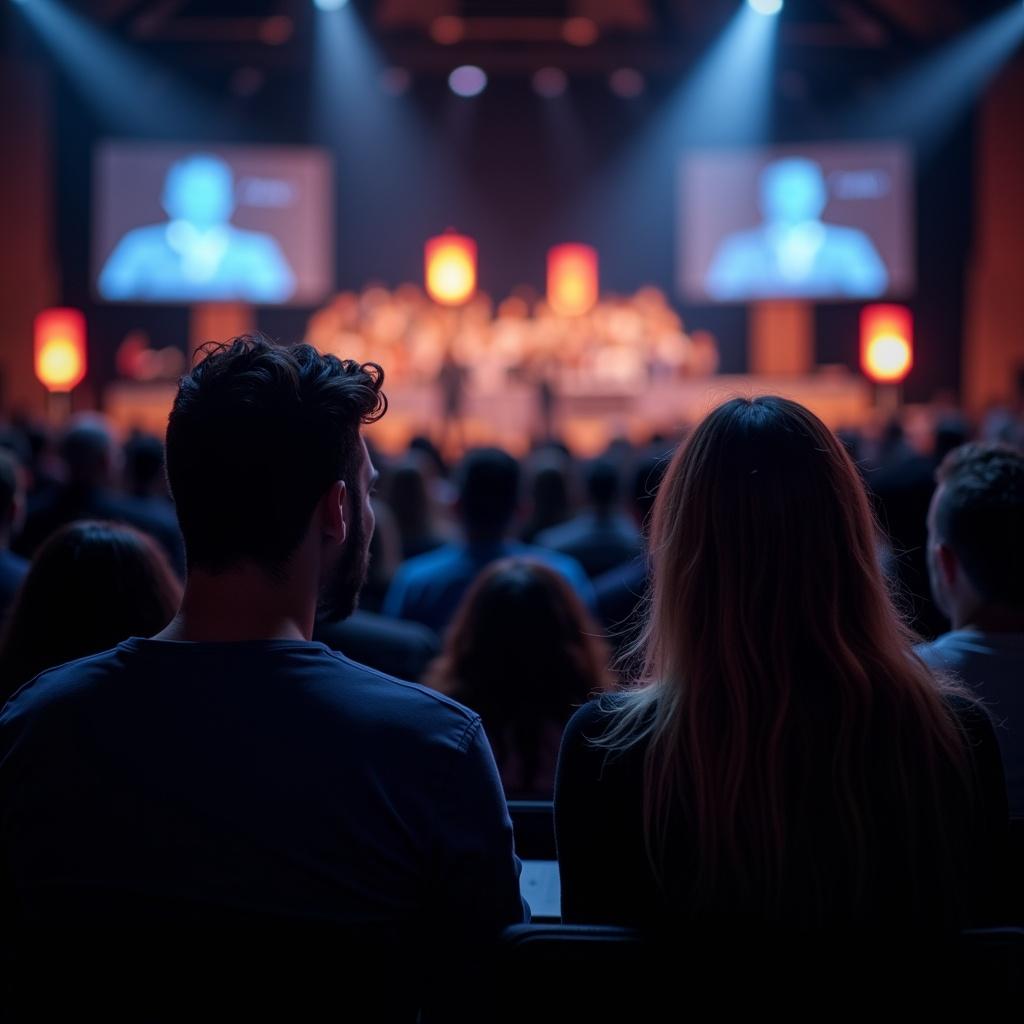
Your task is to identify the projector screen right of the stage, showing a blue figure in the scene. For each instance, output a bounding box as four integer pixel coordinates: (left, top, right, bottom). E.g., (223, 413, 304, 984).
(678, 142, 914, 302)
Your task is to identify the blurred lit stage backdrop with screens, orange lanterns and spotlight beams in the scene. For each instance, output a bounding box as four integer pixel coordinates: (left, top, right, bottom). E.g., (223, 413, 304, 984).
(0, 0, 1024, 454)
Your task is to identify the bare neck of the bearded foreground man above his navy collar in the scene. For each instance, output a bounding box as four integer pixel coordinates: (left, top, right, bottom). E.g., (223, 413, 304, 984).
(154, 566, 316, 643)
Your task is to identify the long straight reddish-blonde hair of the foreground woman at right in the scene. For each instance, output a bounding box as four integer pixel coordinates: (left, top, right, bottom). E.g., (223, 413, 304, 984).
(599, 397, 970, 924)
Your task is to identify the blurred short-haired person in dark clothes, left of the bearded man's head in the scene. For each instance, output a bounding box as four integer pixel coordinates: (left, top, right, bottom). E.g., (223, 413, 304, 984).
(17, 413, 184, 571)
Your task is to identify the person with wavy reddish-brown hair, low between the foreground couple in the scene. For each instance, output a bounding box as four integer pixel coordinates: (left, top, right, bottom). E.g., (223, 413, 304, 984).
(426, 558, 612, 800)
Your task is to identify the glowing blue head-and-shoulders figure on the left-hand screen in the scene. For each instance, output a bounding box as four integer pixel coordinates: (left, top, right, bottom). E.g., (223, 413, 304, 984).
(99, 154, 295, 302)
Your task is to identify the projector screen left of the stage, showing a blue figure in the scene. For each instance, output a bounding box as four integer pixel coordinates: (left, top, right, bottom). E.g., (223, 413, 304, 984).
(93, 142, 334, 305)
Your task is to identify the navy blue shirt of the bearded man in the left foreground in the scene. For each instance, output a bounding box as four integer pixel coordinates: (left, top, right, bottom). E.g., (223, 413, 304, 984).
(0, 639, 523, 940)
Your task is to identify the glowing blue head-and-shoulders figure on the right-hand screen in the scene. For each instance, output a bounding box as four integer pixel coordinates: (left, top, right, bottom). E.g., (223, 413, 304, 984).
(706, 157, 889, 299)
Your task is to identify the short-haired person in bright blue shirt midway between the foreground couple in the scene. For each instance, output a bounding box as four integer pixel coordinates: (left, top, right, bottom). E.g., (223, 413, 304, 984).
(381, 449, 593, 635)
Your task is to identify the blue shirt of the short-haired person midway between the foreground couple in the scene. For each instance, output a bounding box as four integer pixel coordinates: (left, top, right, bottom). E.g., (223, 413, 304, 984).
(381, 541, 594, 633)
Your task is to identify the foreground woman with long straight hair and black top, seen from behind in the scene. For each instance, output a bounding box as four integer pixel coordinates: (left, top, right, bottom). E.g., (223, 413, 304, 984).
(555, 397, 1008, 950)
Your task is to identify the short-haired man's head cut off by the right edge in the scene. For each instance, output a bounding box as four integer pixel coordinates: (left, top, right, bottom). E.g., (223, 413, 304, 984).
(934, 442, 1024, 609)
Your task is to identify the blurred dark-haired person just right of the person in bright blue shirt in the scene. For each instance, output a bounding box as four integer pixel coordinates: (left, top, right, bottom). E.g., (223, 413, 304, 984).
(535, 459, 642, 580)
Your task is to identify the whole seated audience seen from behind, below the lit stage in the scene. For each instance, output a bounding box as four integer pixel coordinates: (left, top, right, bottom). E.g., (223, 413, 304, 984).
(0, 337, 1024, 1019)
